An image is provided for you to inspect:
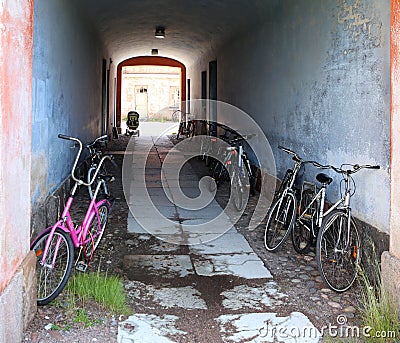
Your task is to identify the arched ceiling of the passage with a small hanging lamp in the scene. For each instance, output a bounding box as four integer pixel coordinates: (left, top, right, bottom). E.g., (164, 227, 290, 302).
(77, 0, 272, 65)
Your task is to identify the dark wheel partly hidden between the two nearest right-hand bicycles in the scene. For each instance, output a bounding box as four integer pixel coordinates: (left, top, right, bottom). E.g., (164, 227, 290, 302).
(292, 190, 317, 254)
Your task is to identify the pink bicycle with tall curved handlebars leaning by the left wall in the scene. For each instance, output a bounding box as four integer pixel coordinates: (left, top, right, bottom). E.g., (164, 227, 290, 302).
(31, 134, 111, 305)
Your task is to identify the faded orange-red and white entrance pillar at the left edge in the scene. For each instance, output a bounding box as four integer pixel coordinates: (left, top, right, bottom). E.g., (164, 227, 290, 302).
(0, 0, 36, 342)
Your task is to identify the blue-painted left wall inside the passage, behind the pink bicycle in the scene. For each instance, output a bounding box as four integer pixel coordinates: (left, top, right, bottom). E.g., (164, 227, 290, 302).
(31, 0, 109, 210)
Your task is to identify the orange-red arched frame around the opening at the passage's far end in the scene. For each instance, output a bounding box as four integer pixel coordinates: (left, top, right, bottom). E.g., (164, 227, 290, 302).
(116, 56, 186, 133)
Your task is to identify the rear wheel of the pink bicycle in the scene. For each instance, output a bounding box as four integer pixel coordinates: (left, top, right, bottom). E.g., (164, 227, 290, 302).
(83, 204, 109, 259)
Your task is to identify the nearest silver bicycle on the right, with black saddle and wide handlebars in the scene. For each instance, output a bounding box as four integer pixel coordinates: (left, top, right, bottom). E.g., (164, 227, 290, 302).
(307, 164, 380, 292)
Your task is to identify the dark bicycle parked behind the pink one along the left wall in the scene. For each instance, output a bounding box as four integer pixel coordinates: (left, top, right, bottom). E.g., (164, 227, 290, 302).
(85, 135, 116, 198)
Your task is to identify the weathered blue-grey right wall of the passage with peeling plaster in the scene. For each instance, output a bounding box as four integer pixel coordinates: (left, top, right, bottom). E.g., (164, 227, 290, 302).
(188, 0, 390, 232)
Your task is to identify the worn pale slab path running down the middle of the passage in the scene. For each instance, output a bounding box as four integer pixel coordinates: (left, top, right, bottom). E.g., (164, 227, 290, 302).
(118, 136, 321, 343)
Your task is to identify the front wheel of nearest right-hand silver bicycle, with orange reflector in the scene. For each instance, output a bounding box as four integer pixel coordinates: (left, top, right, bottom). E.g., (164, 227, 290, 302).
(317, 210, 361, 292)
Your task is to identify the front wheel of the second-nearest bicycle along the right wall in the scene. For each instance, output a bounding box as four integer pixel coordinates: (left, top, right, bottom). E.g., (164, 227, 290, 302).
(264, 192, 296, 252)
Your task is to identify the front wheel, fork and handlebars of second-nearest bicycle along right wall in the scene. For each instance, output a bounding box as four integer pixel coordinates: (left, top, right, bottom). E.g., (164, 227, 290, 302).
(264, 146, 324, 252)
